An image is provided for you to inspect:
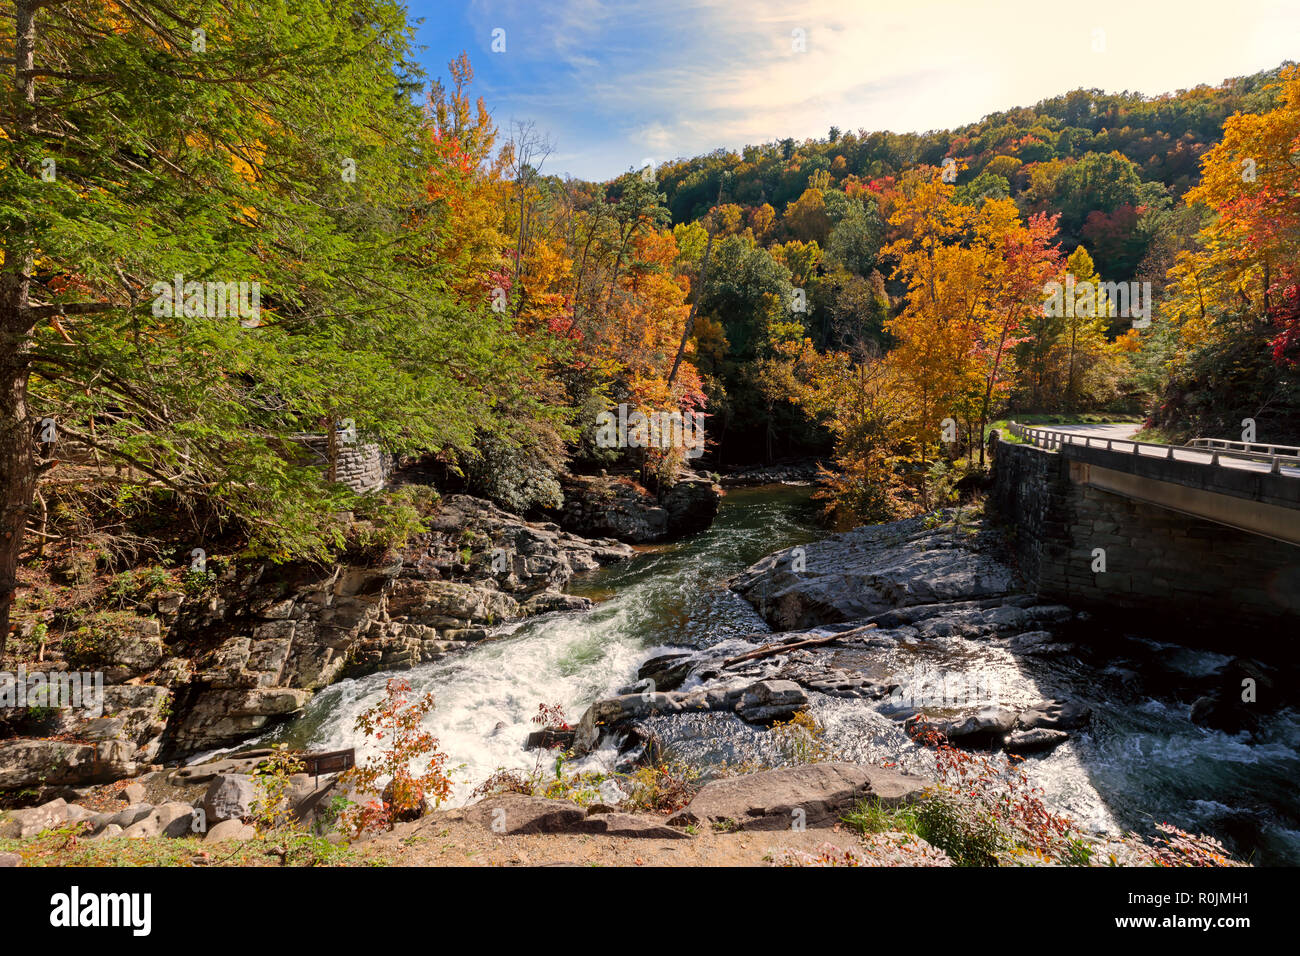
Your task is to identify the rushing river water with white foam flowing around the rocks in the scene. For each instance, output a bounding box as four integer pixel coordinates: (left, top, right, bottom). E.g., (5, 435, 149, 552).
(268, 486, 1300, 864)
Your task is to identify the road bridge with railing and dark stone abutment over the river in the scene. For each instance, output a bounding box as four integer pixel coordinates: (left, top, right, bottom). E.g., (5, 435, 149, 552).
(993, 423, 1300, 624)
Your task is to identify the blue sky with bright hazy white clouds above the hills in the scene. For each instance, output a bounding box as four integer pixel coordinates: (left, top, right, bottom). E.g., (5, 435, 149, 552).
(408, 0, 1300, 181)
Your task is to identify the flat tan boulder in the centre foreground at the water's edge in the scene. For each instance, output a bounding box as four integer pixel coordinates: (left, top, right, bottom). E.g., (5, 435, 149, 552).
(667, 762, 926, 830)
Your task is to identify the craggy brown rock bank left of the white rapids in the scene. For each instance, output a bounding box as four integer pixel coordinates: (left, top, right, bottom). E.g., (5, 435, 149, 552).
(0, 494, 644, 799)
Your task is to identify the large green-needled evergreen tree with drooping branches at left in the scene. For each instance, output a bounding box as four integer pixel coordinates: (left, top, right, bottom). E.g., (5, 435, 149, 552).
(0, 0, 553, 650)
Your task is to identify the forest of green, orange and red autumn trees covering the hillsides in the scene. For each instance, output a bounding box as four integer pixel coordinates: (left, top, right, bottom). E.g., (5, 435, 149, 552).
(0, 0, 1300, 646)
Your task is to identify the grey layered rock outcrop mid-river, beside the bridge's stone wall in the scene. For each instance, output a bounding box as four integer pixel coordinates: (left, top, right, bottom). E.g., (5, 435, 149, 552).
(573, 516, 1089, 765)
